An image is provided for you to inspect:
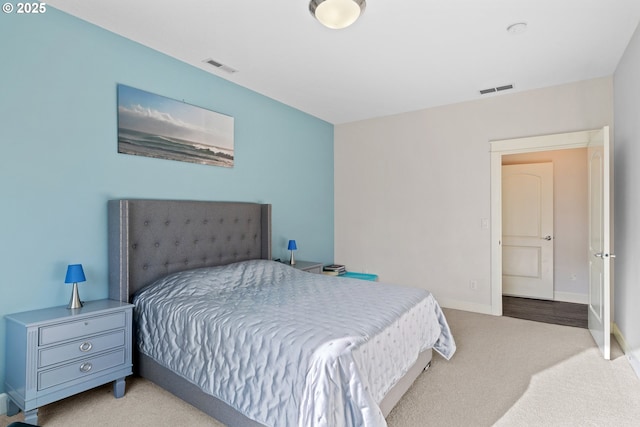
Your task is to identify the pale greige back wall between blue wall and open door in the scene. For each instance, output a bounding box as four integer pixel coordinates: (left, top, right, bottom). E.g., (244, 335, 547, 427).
(334, 77, 613, 313)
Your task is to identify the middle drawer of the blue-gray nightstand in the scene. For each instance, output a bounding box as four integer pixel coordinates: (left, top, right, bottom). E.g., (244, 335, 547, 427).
(38, 329, 125, 368)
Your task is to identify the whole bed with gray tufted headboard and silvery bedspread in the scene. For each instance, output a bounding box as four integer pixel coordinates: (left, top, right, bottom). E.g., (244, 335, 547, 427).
(108, 199, 455, 427)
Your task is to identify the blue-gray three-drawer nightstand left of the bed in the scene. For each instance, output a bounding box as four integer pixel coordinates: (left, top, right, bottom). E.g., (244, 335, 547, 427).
(5, 300, 133, 424)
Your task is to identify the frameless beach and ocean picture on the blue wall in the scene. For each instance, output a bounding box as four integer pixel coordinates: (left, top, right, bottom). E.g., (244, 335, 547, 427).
(118, 84, 234, 167)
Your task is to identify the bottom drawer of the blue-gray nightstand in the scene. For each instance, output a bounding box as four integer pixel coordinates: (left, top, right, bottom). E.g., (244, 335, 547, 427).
(38, 348, 125, 390)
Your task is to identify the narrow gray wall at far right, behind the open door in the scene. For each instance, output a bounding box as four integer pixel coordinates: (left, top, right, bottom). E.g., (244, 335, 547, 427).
(614, 22, 640, 376)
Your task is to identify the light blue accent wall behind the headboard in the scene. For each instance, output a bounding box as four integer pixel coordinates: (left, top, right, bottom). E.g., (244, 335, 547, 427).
(0, 7, 333, 392)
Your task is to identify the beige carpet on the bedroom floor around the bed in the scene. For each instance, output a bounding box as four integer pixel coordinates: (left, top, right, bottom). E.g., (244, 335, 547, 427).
(0, 310, 640, 427)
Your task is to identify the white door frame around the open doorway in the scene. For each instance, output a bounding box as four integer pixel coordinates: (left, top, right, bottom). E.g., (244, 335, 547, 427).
(489, 129, 602, 316)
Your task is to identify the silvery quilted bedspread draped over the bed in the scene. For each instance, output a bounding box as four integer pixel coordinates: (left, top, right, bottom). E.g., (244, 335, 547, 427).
(134, 260, 455, 427)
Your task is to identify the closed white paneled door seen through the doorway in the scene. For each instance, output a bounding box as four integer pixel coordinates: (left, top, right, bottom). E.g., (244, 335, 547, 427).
(502, 163, 554, 300)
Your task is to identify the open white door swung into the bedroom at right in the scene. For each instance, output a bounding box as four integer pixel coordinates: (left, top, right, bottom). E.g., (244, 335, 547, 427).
(588, 126, 614, 359)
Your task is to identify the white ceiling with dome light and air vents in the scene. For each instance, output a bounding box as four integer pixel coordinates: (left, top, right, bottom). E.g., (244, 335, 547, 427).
(47, 0, 640, 124)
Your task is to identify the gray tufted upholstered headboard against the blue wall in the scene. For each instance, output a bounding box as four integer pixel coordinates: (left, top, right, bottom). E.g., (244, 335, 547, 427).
(108, 199, 271, 302)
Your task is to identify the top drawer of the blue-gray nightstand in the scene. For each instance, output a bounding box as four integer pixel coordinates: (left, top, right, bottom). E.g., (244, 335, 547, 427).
(40, 311, 126, 345)
